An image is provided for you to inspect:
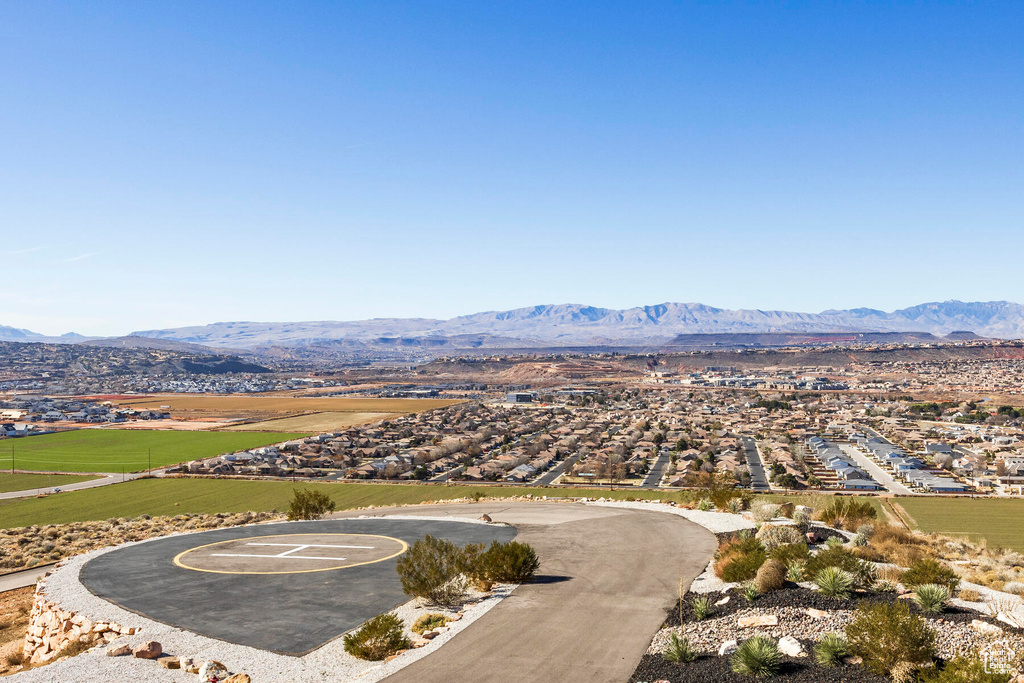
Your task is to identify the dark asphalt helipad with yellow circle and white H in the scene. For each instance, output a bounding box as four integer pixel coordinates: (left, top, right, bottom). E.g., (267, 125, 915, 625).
(80, 518, 516, 654)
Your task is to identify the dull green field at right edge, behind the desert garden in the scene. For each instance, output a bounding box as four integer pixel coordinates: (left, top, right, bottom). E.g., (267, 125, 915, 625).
(895, 496, 1024, 552)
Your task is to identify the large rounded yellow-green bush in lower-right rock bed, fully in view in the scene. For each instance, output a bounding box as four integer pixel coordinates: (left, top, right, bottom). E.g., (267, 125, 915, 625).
(846, 602, 935, 676)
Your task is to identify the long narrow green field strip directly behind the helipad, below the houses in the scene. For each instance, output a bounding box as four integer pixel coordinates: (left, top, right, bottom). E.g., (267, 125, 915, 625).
(0, 478, 696, 528)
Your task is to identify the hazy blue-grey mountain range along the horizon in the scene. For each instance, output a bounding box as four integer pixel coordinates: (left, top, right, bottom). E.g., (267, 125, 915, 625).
(8, 301, 1024, 350)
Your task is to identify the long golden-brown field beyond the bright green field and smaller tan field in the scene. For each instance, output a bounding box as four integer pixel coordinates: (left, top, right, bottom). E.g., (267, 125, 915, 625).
(111, 394, 461, 422)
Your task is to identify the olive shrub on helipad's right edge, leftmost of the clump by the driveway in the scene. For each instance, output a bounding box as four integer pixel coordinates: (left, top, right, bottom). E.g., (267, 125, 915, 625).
(396, 536, 466, 605)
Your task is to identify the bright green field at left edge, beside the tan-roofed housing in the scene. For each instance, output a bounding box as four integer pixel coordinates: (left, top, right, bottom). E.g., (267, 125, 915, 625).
(0, 429, 308, 472)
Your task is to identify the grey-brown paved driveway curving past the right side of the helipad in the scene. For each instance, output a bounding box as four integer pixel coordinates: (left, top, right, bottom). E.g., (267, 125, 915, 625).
(372, 502, 717, 683)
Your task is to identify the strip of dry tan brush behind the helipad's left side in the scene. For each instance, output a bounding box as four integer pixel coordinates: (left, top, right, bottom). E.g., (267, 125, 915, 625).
(0, 512, 280, 571)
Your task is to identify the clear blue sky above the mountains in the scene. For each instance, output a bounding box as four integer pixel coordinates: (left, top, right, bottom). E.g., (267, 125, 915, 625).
(0, 0, 1024, 334)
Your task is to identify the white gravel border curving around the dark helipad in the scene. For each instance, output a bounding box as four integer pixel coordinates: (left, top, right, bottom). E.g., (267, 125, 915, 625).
(9, 515, 517, 683)
